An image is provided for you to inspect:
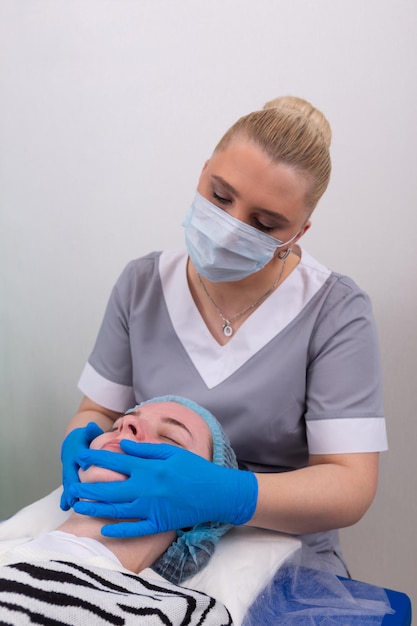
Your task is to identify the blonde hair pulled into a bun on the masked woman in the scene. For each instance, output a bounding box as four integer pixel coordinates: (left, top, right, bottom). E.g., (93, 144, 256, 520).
(215, 96, 332, 212)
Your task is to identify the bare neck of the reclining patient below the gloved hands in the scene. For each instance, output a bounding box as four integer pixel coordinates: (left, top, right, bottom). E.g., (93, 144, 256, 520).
(57, 512, 176, 573)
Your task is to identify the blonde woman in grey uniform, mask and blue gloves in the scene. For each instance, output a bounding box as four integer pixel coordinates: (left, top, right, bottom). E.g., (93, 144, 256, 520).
(61, 97, 386, 574)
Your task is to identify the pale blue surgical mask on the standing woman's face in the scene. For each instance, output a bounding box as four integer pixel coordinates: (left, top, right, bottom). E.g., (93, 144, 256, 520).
(182, 193, 298, 283)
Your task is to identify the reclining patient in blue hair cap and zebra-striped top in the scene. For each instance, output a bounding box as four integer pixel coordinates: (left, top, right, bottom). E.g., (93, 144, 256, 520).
(0, 396, 237, 626)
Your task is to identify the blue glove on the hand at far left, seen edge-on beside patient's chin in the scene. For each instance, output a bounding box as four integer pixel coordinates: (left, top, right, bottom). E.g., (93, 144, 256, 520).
(60, 422, 103, 511)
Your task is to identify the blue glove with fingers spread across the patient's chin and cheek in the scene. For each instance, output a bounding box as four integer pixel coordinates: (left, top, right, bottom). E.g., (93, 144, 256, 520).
(70, 439, 258, 537)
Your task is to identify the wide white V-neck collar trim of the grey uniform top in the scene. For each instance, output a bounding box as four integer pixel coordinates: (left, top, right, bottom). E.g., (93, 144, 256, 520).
(159, 251, 331, 389)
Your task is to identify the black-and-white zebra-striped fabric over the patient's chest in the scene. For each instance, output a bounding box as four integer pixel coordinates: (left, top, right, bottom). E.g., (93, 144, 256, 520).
(0, 560, 232, 626)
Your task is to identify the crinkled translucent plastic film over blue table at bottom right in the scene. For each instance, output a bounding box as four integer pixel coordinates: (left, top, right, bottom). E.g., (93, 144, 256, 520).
(242, 558, 393, 626)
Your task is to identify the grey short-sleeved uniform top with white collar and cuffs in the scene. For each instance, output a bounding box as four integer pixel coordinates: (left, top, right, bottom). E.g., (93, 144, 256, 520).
(79, 246, 386, 472)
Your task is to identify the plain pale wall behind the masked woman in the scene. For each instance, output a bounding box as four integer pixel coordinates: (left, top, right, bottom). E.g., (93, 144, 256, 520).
(0, 0, 417, 602)
